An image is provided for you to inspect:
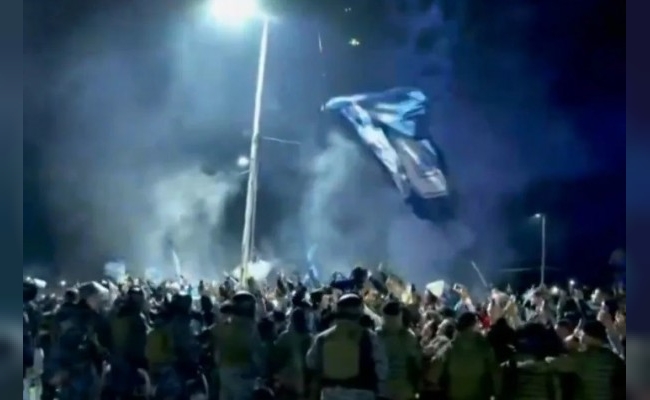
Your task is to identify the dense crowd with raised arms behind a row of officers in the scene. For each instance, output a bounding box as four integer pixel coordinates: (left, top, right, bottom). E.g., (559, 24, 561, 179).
(23, 267, 626, 400)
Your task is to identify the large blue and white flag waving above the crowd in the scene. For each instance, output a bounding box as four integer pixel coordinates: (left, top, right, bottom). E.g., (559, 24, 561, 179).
(324, 87, 449, 219)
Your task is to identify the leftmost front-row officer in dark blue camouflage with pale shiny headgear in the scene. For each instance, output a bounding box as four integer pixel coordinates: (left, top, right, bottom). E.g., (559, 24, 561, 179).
(48, 282, 110, 400)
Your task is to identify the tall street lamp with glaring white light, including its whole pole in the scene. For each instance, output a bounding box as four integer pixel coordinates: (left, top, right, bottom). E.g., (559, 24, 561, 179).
(210, 0, 269, 284)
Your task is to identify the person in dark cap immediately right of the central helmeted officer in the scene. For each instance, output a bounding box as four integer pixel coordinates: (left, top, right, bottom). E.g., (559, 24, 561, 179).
(377, 300, 422, 400)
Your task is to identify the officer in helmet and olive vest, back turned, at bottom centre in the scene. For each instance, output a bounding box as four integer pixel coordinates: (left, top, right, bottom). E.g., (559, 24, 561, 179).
(306, 294, 389, 400)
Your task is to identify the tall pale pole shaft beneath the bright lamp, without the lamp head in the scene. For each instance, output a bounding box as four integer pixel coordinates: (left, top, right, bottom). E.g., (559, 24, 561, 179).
(239, 18, 269, 285)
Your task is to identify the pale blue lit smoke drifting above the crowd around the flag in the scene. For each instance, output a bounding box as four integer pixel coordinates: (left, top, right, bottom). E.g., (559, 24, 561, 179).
(30, 0, 588, 280)
